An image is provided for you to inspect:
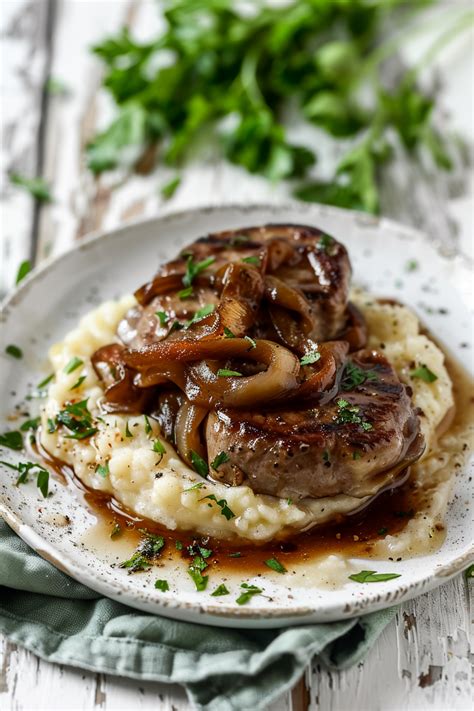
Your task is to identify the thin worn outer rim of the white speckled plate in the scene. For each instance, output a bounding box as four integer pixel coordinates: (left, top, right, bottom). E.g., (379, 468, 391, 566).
(0, 200, 474, 626)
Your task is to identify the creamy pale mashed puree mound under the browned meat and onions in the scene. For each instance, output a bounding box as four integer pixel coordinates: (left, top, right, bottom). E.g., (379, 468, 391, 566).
(41, 292, 456, 544)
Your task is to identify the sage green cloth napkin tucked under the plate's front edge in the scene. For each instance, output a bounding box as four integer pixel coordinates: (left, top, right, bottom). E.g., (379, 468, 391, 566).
(0, 519, 395, 711)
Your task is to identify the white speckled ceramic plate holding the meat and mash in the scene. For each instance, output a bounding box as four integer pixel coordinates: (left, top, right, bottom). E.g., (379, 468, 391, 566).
(0, 204, 473, 627)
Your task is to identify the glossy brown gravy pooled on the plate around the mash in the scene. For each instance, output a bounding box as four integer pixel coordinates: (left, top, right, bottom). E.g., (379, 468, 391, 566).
(37, 357, 474, 575)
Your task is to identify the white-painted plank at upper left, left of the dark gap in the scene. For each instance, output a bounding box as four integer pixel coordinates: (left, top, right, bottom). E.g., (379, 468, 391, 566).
(0, 0, 50, 296)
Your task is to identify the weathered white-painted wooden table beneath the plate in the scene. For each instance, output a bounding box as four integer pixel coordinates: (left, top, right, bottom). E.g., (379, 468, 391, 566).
(0, 0, 474, 711)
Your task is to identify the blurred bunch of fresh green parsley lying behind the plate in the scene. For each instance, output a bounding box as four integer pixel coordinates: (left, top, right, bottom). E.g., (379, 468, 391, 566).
(88, 0, 472, 212)
